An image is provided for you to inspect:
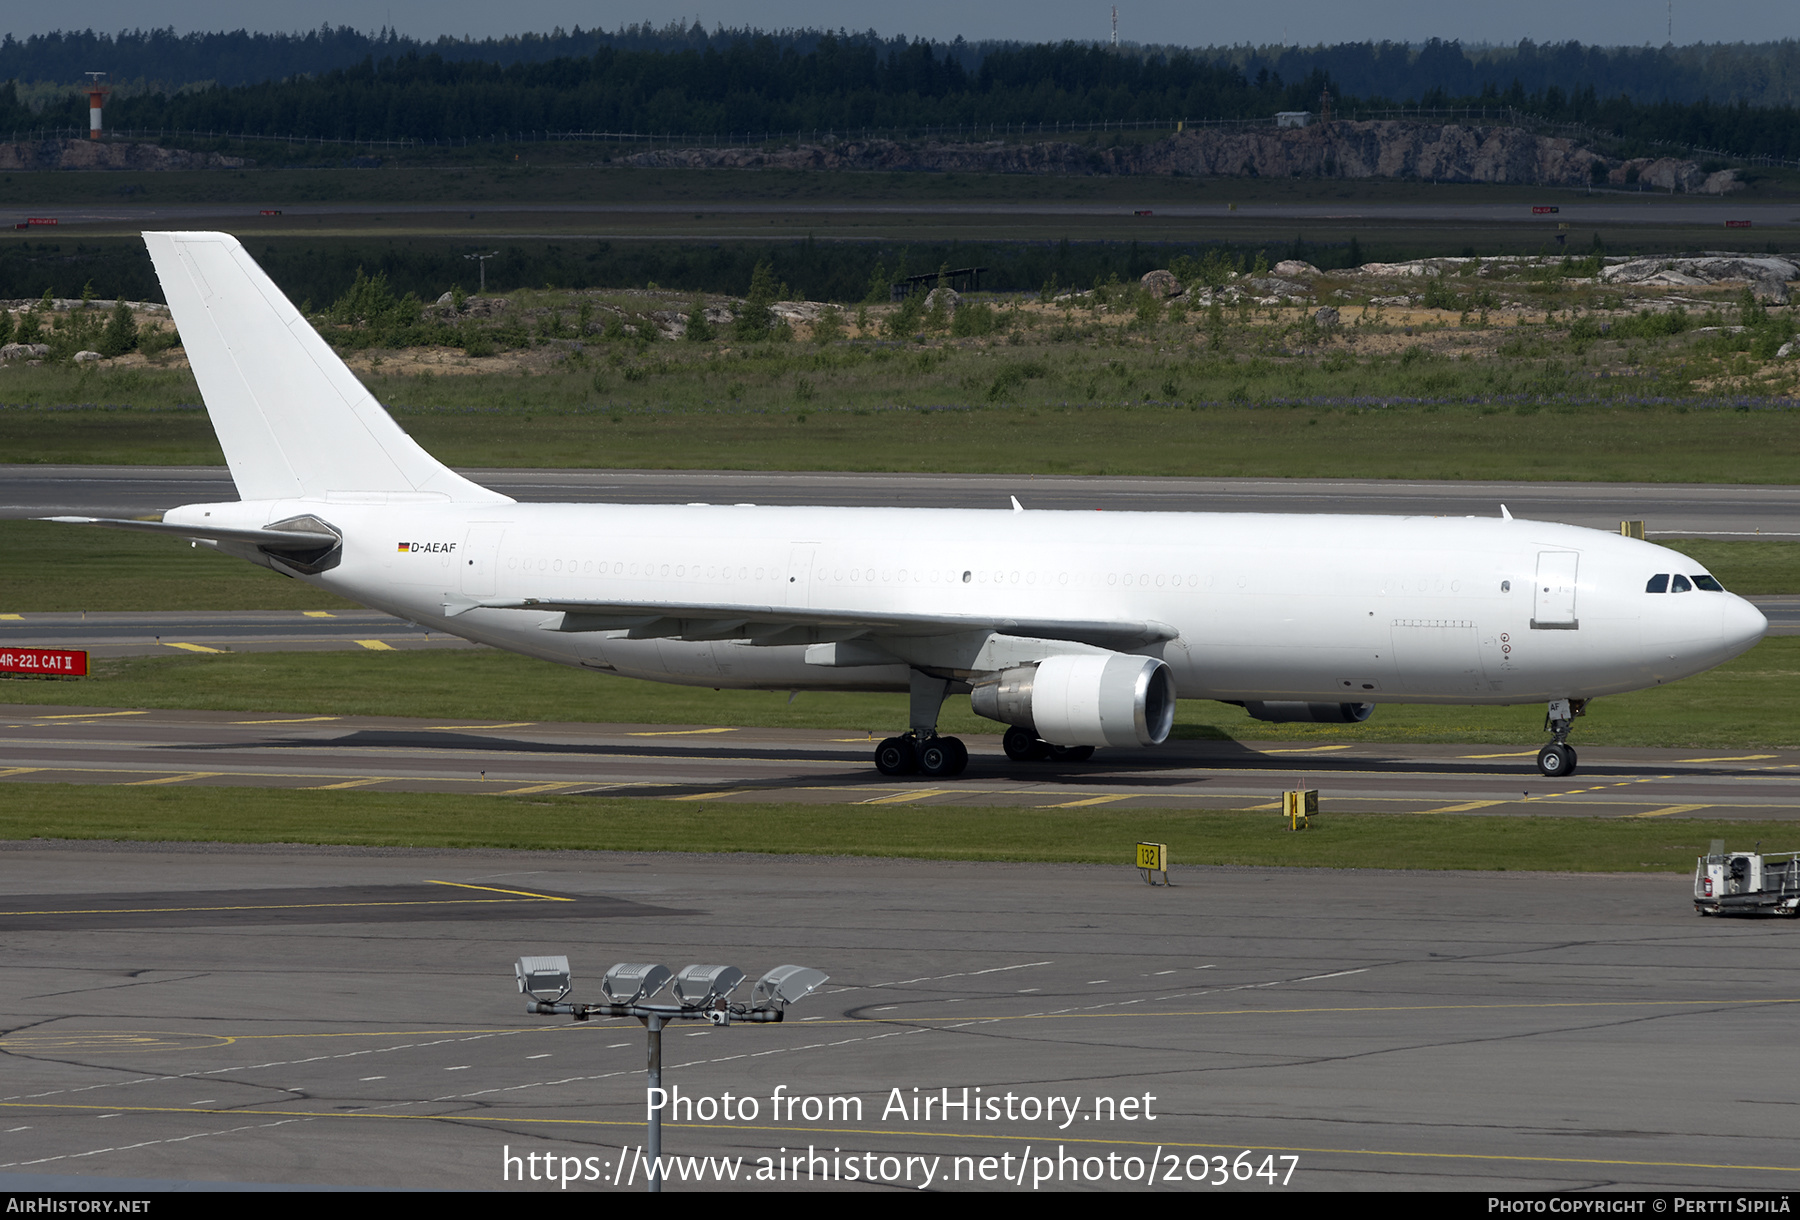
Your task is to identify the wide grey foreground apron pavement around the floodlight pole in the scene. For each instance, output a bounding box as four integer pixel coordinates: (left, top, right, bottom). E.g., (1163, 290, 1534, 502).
(0, 840, 1800, 1195)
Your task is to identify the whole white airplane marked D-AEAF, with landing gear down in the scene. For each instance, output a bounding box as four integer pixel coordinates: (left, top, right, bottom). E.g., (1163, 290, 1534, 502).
(52, 232, 1768, 776)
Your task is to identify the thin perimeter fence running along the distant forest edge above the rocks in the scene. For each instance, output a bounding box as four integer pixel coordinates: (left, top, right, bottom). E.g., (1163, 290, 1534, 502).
(11, 106, 1800, 169)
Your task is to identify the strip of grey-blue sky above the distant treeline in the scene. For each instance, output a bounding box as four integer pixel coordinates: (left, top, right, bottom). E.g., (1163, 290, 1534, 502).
(5, 0, 1800, 45)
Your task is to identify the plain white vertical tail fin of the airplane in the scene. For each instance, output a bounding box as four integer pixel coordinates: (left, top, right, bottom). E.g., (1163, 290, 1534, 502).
(144, 232, 509, 504)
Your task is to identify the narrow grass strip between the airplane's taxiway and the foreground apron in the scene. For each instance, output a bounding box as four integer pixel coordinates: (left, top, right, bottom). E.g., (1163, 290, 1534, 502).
(0, 783, 1771, 874)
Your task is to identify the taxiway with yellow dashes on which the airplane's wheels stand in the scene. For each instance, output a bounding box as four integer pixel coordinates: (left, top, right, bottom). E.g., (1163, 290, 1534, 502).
(0, 707, 1800, 822)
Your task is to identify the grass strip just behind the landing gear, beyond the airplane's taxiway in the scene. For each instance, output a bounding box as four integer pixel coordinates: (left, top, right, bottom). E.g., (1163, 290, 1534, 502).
(10, 637, 1800, 749)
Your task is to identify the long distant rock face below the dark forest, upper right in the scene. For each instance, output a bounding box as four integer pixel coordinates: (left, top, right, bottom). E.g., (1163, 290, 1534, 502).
(614, 121, 1741, 194)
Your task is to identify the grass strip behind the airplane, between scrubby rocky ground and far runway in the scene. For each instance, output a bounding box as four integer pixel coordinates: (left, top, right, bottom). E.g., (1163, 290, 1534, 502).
(10, 395, 1800, 485)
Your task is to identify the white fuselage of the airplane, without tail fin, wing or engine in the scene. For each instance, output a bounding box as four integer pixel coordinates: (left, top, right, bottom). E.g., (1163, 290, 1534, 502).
(166, 500, 1768, 704)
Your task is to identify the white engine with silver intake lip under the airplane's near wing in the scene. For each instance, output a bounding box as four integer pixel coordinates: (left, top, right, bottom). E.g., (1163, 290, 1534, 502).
(968, 653, 1175, 745)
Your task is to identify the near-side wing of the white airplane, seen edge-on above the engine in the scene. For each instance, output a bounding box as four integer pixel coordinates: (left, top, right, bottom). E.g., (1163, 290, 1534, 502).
(468, 597, 1179, 648)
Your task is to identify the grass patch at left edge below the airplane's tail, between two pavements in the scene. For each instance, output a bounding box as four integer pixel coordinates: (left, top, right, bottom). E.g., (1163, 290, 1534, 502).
(0, 522, 351, 614)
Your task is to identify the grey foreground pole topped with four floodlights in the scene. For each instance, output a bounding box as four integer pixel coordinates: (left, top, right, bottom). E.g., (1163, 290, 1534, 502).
(514, 957, 830, 1195)
